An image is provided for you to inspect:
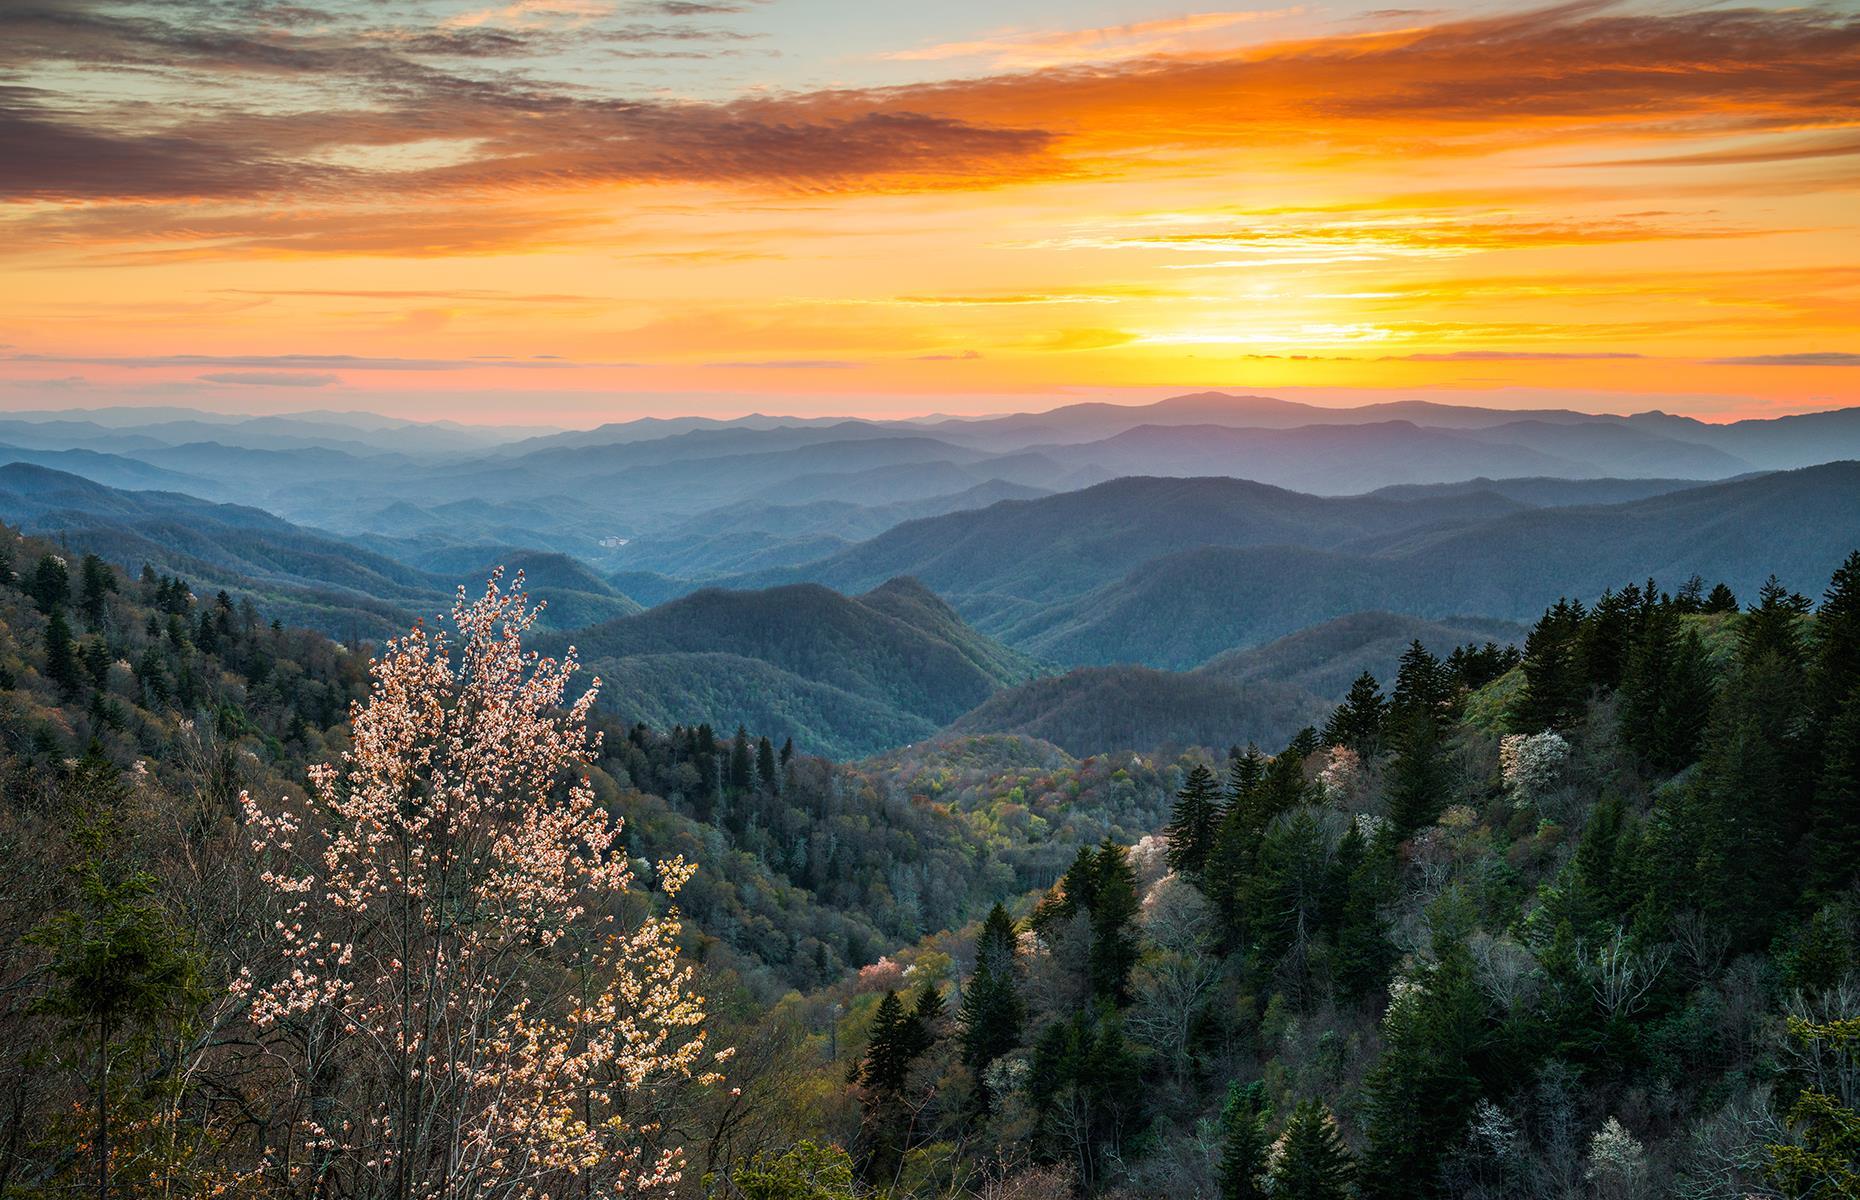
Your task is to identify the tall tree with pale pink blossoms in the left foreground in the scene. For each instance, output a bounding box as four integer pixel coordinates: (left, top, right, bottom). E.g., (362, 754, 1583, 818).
(234, 575, 727, 1200)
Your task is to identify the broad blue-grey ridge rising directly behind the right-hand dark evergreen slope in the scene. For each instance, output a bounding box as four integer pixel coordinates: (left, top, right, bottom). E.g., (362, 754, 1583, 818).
(744, 461, 1860, 668)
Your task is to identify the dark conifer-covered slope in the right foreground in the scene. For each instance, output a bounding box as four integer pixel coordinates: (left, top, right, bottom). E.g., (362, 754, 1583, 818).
(691, 551, 1860, 1200)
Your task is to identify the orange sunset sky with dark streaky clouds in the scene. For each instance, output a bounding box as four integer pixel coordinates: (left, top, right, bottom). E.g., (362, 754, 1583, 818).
(0, 0, 1860, 426)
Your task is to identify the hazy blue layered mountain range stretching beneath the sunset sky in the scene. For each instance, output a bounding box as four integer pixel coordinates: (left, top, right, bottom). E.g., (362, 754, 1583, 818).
(0, 393, 1860, 757)
